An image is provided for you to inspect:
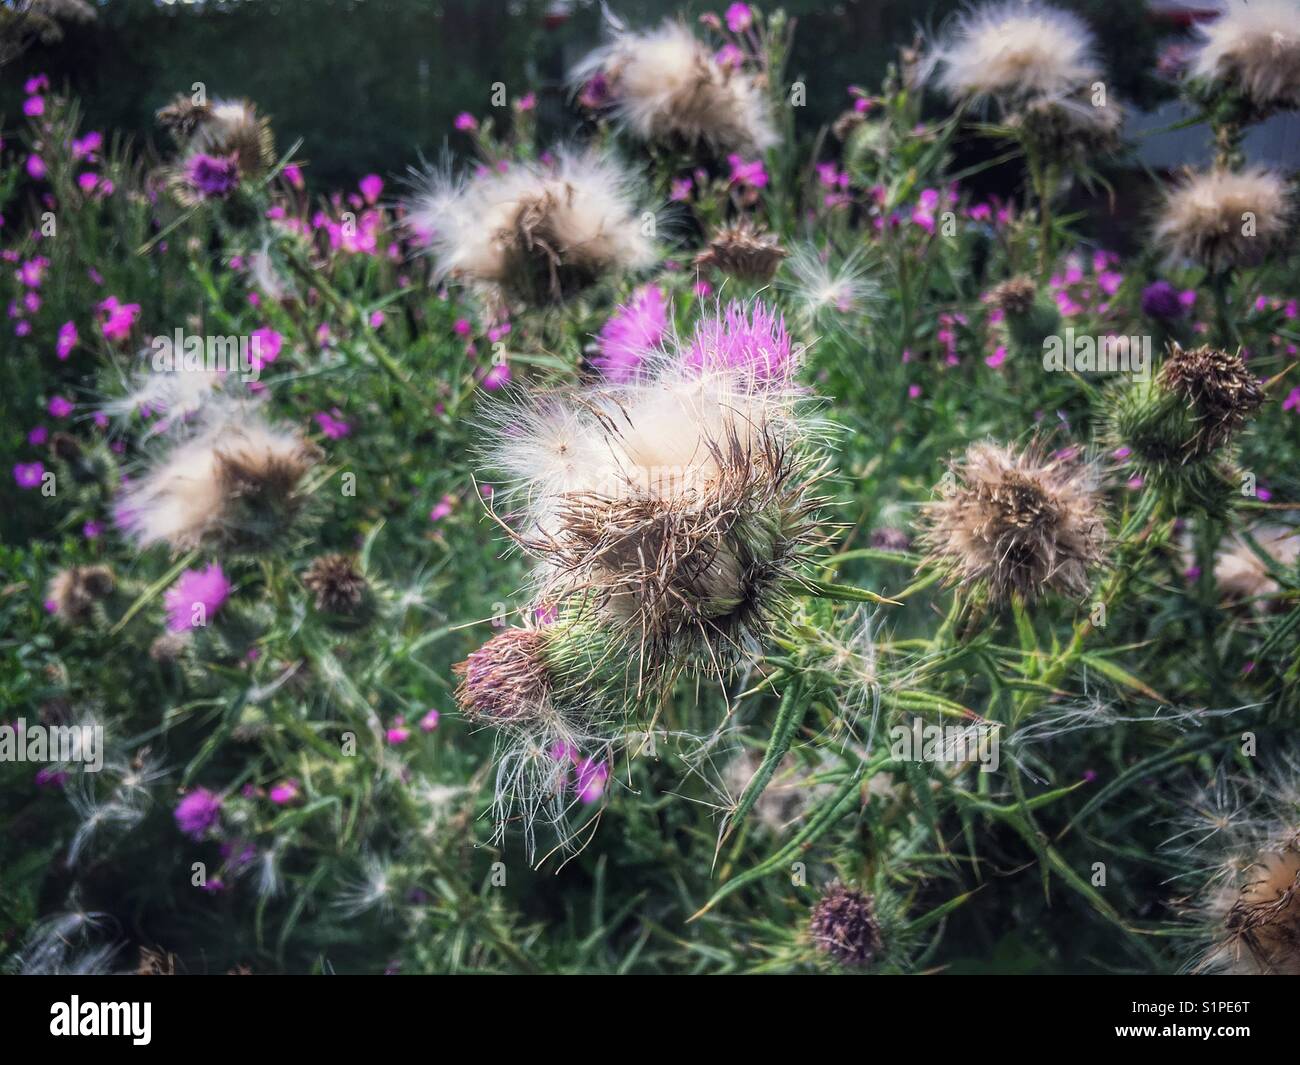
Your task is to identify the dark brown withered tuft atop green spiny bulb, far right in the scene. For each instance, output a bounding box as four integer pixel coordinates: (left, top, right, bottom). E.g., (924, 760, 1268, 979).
(1158, 343, 1265, 456)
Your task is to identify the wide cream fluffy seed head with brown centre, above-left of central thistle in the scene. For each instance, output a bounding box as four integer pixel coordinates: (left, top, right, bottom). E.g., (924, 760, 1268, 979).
(407, 151, 657, 304)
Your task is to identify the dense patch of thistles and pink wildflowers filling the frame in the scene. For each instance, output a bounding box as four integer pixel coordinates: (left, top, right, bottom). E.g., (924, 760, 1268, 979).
(0, 0, 1300, 974)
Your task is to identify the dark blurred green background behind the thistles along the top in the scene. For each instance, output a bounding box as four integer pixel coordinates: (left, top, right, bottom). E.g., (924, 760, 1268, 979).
(0, 0, 1177, 187)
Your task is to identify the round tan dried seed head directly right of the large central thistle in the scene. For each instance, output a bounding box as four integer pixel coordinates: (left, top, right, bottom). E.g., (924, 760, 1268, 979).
(923, 443, 1105, 602)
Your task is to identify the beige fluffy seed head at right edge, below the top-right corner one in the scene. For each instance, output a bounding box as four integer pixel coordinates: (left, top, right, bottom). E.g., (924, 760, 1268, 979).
(1154, 166, 1291, 270)
